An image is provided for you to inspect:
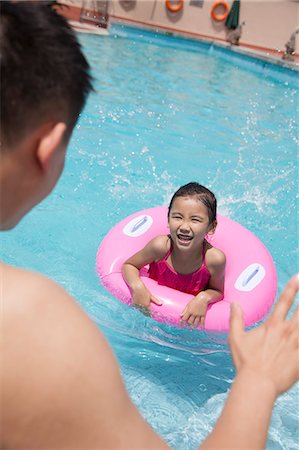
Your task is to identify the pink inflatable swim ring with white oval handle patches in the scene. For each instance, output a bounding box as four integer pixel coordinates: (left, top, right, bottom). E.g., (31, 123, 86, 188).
(96, 207, 277, 331)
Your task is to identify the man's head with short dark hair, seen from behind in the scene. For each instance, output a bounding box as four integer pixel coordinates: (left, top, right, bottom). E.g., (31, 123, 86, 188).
(0, 1, 92, 229)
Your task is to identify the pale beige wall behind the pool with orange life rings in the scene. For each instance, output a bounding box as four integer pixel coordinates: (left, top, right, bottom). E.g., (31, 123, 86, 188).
(109, 0, 299, 53)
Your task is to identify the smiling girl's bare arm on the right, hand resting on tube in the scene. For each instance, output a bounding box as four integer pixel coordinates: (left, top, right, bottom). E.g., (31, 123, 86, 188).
(181, 248, 226, 328)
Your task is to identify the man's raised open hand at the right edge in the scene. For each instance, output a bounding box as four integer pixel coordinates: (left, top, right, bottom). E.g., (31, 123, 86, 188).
(229, 274, 299, 396)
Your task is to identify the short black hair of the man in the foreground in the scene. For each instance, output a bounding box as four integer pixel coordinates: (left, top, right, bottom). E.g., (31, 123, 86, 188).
(0, 1, 92, 146)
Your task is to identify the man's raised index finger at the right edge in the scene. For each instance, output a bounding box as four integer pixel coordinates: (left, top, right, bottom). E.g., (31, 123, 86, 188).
(266, 274, 299, 324)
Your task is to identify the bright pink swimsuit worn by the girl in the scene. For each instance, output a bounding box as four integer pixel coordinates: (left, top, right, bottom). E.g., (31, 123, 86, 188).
(148, 241, 211, 296)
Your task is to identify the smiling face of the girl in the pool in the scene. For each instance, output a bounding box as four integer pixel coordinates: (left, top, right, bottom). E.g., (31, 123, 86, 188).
(168, 197, 214, 250)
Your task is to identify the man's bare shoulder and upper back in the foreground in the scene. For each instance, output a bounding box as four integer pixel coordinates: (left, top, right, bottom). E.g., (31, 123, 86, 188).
(0, 264, 167, 449)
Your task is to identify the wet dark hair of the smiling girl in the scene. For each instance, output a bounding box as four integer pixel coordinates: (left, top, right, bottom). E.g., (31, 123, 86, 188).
(168, 181, 217, 225)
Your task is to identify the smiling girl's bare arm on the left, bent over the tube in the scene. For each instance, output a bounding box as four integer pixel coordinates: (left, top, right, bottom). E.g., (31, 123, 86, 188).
(122, 236, 169, 308)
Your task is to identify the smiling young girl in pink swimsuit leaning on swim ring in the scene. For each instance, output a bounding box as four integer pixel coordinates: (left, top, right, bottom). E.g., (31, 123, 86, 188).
(123, 182, 225, 328)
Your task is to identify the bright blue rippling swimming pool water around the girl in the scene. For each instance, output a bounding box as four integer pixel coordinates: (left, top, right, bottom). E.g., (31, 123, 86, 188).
(2, 27, 299, 450)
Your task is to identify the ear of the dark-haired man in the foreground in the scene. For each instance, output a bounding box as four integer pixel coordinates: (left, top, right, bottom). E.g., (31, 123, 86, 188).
(36, 122, 66, 172)
